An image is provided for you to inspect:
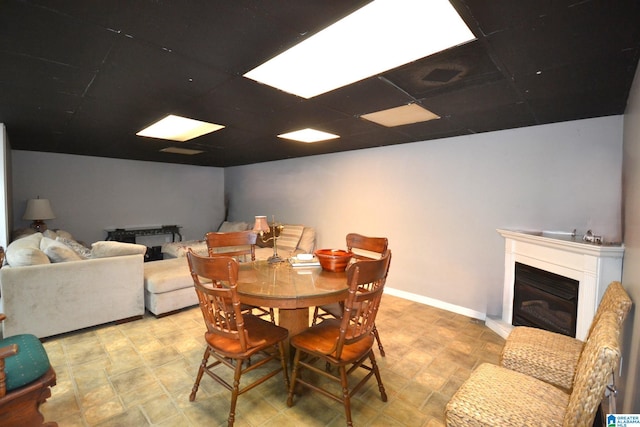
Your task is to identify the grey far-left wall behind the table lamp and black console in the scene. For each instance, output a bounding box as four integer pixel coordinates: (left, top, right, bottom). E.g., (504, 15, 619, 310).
(12, 150, 224, 245)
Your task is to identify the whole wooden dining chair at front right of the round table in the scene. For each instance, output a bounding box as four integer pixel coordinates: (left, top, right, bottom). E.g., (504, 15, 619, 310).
(287, 251, 391, 426)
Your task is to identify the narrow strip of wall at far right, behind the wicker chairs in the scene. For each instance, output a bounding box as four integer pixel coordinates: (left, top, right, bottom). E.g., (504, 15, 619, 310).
(618, 61, 640, 414)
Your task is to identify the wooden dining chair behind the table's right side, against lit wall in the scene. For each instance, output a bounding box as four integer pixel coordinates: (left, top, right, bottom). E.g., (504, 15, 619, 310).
(311, 233, 389, 357)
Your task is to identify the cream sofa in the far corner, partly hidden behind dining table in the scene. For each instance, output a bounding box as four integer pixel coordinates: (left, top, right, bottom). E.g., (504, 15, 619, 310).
(144, 222, 316, 316)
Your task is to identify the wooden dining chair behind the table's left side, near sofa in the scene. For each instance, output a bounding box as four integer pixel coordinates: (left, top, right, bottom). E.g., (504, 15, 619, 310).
(204, 230, 276, 324)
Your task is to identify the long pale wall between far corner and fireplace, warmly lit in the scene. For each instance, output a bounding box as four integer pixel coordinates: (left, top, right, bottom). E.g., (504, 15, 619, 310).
(225, 116, 623, 318)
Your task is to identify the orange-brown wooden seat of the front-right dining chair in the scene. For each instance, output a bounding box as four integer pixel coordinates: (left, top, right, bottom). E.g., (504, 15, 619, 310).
(291, 319, 374, 366)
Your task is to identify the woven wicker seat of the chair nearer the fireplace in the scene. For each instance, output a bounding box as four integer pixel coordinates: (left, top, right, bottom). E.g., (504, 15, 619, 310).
(500, 326, 584, 390)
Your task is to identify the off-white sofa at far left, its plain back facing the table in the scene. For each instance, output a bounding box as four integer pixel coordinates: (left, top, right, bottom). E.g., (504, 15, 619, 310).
(0, 233, 146, 338)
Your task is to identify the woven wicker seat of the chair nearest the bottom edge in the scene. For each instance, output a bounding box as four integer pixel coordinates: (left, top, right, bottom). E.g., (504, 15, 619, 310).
(445, 363, 569, 427)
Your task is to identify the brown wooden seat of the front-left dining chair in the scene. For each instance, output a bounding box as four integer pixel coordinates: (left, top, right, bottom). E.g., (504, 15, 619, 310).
(205, 314, 288, 359)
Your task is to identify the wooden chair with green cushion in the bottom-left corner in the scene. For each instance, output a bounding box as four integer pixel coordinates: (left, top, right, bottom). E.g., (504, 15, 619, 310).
(0, 314, 58, 427)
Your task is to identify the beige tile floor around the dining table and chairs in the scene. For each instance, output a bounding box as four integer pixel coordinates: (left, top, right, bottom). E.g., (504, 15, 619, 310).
(42, 295, 504, 427)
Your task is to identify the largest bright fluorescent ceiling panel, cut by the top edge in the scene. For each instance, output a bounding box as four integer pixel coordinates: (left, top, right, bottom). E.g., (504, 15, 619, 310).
(244, 0, 475, 98)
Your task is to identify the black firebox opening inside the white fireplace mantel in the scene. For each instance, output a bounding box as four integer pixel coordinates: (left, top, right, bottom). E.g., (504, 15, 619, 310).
(511, 262, 579, 337)
